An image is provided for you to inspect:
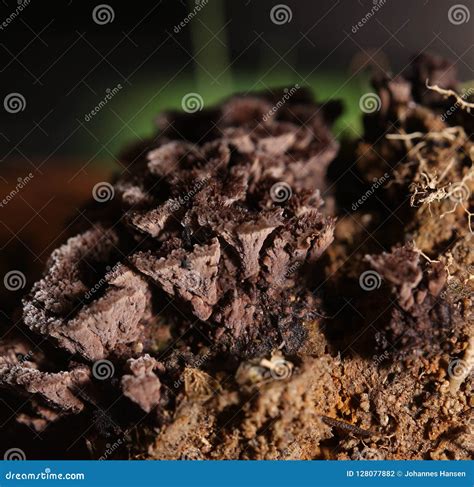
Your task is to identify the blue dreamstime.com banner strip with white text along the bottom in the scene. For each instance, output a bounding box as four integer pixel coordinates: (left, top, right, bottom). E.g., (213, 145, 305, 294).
(0, 460, 474, 487)
